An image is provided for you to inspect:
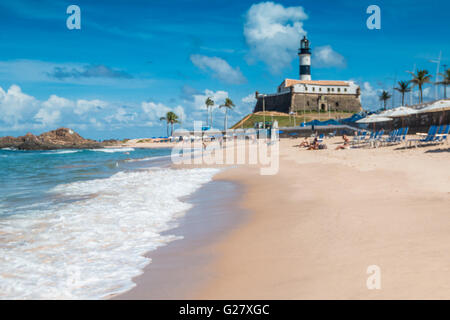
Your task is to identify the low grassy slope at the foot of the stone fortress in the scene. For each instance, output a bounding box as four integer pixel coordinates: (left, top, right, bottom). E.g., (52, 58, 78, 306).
(231, 111, 353, 129)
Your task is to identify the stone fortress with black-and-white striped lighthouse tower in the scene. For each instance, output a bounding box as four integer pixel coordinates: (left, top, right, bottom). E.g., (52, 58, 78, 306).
(254, 36, 361, 113)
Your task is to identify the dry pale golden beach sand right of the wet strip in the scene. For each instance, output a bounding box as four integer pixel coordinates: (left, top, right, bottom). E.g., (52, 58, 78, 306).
(119, 138, 450, 299)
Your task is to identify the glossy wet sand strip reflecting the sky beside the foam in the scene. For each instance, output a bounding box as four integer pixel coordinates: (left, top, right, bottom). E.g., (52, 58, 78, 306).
(110, 173, 248, 300)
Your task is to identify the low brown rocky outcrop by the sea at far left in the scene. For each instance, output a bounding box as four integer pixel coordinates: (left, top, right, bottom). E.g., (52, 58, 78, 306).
(0, 128, 104, 150)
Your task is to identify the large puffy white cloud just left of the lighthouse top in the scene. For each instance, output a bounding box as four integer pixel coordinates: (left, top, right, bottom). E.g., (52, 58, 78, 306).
(244, 2, 308, 73)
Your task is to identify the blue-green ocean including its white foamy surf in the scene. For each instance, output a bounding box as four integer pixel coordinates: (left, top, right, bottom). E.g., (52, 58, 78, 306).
(0, 148, 218, 299)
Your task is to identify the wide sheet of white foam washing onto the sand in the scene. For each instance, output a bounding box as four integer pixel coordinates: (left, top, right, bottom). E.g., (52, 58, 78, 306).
(0, 169, 218, 299)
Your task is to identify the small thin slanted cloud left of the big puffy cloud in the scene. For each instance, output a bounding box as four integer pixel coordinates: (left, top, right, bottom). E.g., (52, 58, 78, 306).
(190, 54, 247, 84)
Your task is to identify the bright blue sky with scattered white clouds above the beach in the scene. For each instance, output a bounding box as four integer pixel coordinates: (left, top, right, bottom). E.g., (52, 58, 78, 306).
(0, 0, 450, 139)
